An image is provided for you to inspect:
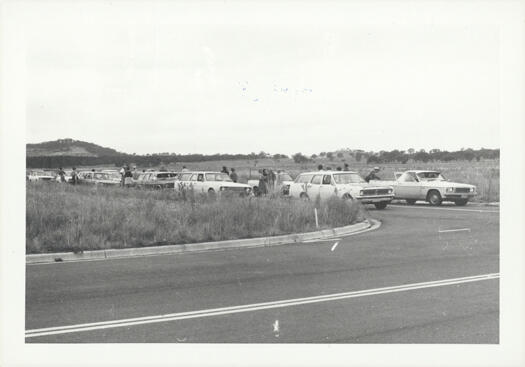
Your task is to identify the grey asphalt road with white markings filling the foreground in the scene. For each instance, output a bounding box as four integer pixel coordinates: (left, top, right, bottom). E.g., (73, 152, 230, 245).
(26, 205, 499, 343)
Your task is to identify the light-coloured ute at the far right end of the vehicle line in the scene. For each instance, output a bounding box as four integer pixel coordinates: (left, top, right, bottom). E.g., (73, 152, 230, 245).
(371, 170, 477, 206)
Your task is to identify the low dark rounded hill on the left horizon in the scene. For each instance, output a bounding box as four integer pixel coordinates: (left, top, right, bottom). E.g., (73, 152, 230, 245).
(26, 139, 123, 157)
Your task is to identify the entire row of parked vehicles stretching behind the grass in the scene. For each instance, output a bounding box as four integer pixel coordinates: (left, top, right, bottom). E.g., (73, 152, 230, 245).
(27, 170, 477, 209)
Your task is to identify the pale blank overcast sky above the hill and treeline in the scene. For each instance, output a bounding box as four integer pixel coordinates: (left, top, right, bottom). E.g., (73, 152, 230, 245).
(25, 2, 500, 154)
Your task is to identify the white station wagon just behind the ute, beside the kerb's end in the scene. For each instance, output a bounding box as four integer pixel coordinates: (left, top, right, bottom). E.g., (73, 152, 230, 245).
(290, 171, 394, 209)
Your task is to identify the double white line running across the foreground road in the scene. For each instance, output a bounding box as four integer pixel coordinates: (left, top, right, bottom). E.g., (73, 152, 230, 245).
(25, 273, 499, 338)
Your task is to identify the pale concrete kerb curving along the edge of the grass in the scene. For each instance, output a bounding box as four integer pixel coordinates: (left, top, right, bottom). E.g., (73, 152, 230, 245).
(26, 219, 381, 264)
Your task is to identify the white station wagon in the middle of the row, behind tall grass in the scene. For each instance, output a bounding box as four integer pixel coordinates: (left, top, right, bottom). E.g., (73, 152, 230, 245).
(176, 171, 252, 196)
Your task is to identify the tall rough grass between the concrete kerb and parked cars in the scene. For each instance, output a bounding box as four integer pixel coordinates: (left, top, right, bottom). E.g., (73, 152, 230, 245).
(26, 182, 365, 254)
